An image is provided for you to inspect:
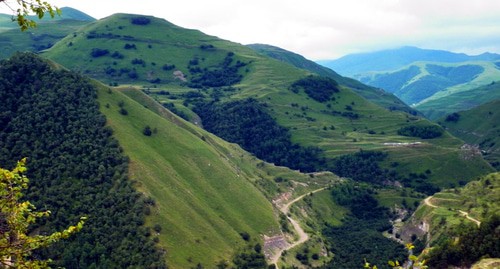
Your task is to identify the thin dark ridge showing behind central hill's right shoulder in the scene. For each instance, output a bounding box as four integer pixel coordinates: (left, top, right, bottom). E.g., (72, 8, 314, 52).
(247, 44, 413, 112)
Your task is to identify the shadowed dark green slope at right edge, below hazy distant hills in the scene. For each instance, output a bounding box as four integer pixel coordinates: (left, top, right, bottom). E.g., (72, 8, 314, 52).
(440, 100, 500, 169)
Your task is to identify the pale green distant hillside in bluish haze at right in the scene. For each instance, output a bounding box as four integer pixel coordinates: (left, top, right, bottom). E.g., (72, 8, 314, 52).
(358, 61, 500, 119)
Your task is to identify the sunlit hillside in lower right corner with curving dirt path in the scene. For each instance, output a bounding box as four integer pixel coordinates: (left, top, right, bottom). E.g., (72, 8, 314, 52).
(399, 173, 500, 268)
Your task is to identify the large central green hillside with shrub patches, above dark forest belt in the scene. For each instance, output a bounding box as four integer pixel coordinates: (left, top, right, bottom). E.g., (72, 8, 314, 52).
(43, 14, 491, 186)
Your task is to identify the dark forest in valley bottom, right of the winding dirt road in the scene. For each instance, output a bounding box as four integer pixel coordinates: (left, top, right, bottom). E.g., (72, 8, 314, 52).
(322, 182, 407, 269)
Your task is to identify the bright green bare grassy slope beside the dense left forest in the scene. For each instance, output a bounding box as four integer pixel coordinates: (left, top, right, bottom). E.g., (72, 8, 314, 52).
(98, 84, 284, 268)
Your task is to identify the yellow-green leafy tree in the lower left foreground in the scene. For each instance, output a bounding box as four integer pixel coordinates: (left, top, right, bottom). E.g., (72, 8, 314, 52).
(0, 159, 85, 268)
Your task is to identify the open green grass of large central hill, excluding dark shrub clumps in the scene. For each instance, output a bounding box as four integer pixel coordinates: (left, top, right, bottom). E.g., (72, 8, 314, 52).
(40, 14, 490, 189)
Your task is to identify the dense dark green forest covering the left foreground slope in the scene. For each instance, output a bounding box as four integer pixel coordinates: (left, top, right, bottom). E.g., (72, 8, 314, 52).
(0, 53, 166, 268)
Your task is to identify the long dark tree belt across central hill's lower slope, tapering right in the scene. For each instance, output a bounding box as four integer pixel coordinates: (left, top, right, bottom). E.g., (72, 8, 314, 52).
(193, 98, 439, 194)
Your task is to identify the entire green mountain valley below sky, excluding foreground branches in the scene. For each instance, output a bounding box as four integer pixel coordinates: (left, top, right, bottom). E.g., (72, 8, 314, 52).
(0, 5, 500, 269)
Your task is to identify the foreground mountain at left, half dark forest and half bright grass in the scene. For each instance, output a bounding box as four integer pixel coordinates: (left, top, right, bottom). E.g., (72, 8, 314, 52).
(0, 51, 338, 268)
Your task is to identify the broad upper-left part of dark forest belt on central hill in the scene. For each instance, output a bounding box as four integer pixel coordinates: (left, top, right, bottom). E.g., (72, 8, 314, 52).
(194, 98, 325, 172)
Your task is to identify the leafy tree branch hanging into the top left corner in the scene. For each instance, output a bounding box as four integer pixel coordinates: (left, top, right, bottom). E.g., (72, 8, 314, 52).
(0, 0, 61, 31)
